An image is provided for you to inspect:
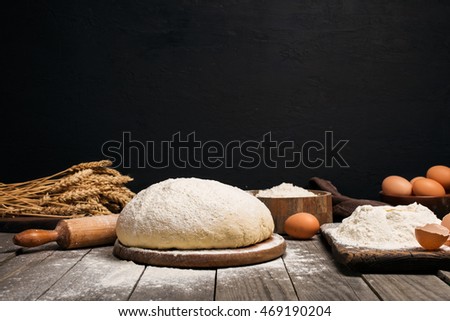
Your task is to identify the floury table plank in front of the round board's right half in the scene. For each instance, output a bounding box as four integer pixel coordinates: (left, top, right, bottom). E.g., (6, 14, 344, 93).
(215, 258, 297, 301)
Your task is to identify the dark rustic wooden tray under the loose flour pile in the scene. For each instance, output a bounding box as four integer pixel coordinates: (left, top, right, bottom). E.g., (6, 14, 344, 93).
(320, 223, 450, 273)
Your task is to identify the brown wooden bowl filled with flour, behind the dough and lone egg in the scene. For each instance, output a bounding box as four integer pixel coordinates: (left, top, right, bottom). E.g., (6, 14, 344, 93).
(250, 190, 333, 234)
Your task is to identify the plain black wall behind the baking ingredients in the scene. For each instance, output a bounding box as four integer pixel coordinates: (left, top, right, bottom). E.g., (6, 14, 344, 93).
(0, 0, 450, 198)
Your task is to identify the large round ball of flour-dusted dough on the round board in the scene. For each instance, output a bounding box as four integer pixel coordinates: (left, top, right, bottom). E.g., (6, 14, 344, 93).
(116, 178, 274, 249)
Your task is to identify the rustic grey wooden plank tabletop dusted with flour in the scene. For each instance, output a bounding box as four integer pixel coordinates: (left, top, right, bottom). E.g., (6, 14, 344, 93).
(0, 233, 450, 301)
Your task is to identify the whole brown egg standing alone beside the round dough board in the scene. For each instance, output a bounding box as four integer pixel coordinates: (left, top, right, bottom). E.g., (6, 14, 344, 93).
(284, 212, 320, 239)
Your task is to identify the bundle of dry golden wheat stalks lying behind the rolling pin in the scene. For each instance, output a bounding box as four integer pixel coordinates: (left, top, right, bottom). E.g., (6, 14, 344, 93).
(0, 160, 134, 218)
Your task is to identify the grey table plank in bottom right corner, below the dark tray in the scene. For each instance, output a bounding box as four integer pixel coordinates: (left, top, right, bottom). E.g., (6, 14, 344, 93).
(363, 274, 450, 301)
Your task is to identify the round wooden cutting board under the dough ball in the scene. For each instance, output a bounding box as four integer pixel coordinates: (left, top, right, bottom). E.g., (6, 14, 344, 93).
(113, 234, 286, 268)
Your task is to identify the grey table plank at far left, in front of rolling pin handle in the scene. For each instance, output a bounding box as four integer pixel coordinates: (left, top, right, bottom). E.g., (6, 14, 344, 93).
(0, 249, 89, 301)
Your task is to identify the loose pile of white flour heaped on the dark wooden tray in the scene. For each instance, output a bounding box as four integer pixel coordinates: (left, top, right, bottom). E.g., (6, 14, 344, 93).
(331, 203, 441, 250)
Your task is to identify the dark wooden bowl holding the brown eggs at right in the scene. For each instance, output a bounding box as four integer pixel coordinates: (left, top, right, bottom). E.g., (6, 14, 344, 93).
(380, 192, 450, 219)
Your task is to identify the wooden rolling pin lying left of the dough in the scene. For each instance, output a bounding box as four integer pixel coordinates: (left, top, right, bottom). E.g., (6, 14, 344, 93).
(13, 214, 119, 249)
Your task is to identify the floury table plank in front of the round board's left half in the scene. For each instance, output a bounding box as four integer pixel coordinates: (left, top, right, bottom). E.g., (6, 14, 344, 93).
(130, 266, 216, 301)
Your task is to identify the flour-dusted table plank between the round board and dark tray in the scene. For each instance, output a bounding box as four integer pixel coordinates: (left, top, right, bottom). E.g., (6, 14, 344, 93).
(284, 236, 378, 301)
